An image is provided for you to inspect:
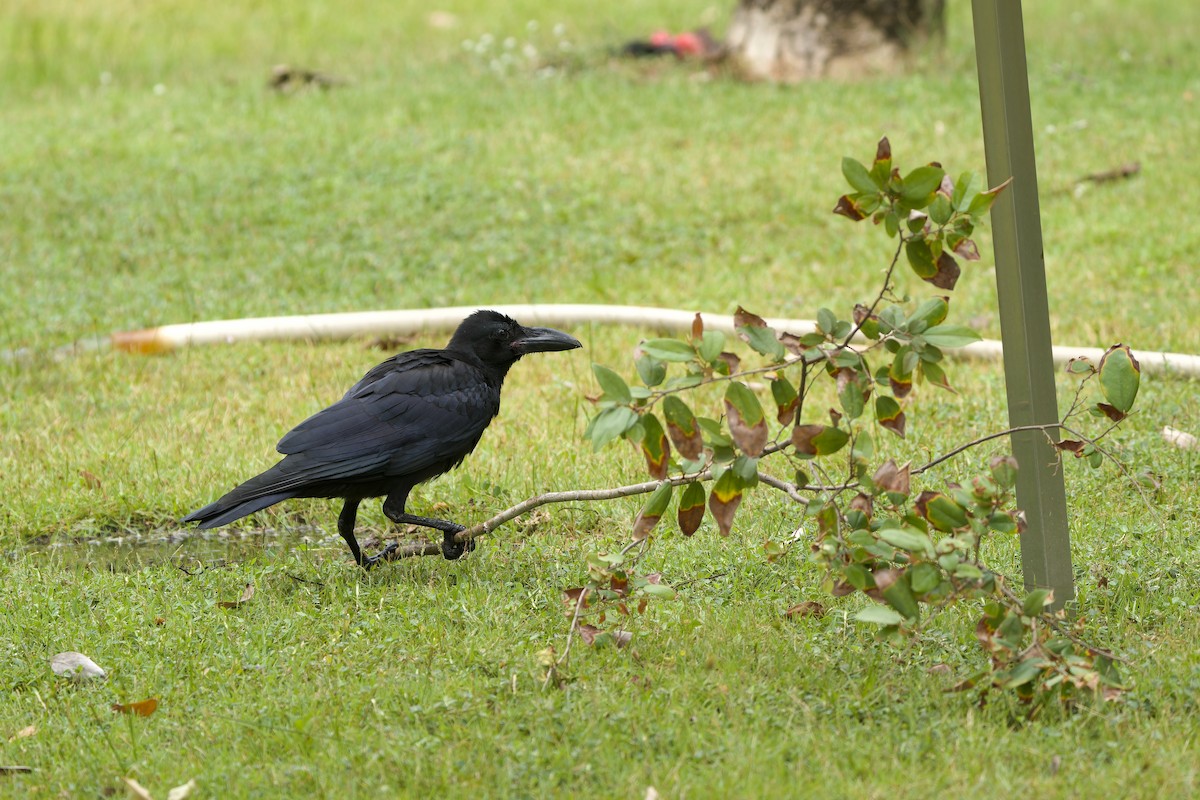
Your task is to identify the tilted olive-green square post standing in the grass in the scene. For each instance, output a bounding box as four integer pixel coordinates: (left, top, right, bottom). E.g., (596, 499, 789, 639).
(972, 0, 1075, 608)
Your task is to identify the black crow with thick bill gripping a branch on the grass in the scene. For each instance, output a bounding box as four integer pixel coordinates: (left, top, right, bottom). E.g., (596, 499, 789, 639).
(182, 311, 582, 569)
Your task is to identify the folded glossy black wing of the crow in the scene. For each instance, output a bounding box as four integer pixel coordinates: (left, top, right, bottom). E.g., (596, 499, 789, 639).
(277, 350, 499, 480)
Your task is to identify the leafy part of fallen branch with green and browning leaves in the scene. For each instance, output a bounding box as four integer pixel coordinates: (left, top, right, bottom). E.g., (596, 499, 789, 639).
(564, 138, 1140, 708)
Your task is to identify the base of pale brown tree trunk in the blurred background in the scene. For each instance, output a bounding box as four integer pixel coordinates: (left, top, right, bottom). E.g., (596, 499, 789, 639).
(726, 0, 946, 82)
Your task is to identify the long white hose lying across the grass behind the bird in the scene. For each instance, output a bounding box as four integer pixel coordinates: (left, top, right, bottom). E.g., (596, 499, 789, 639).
(21, 303, 1200, 377)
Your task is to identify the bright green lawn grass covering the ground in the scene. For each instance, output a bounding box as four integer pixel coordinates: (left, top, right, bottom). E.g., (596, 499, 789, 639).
(0, 0, 1200, 798)
